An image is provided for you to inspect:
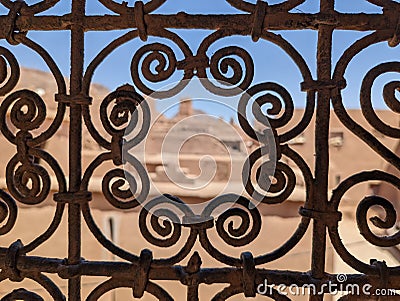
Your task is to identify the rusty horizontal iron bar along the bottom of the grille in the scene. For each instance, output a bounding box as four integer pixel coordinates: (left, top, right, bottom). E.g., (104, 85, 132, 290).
(0, 253, 400, 290)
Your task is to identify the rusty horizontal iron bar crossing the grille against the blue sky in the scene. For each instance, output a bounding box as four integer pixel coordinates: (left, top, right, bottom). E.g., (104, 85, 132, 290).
(0, 12, 397, 35)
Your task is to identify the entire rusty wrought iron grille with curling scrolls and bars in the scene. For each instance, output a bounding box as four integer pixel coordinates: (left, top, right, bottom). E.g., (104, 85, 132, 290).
(0, 0, 400, 301)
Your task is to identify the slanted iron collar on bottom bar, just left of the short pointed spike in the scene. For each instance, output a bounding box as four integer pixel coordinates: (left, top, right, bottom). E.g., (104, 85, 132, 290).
(132, 249, 153, 298)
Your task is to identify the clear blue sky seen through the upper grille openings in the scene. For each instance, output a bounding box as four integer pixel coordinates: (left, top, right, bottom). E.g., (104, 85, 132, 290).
(0, 0, 400, 117)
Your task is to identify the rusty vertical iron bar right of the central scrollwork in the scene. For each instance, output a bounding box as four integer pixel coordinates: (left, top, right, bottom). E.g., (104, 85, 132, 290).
(310, 0, 335, 301)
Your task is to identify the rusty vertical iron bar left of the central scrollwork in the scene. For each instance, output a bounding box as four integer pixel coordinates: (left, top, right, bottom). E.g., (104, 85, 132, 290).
(68, 0, 86, 301)
